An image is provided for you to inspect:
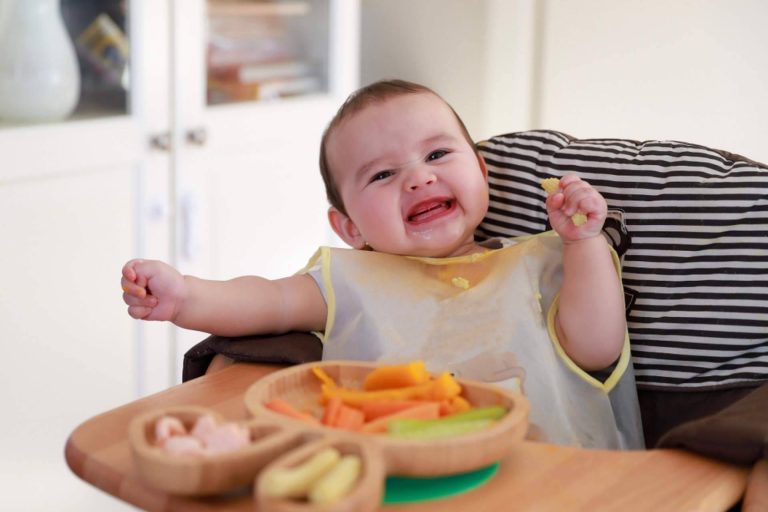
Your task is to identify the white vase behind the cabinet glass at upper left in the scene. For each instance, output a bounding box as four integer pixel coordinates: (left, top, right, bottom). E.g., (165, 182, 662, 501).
(0, 0, 80, 122)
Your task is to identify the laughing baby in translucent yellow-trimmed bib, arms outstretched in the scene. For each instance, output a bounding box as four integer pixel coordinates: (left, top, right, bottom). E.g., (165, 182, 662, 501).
(122, 80, 642, 448)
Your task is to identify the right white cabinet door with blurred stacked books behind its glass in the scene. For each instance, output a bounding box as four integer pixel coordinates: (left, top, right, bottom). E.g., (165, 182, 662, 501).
(169, 0, 358, 368)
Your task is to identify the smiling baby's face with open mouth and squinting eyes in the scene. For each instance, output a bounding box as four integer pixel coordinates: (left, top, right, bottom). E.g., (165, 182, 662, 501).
(326, 93, 488, 257)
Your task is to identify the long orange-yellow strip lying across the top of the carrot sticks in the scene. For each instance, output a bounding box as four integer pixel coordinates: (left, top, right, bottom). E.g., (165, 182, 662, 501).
(321, 372, 461, 407)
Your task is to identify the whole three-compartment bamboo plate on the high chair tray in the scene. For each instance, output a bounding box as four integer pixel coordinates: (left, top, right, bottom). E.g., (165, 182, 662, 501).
(129, 361, 529, 512)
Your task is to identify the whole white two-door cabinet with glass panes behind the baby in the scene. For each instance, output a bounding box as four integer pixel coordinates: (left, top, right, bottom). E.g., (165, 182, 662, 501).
(0, 0, 358, 510)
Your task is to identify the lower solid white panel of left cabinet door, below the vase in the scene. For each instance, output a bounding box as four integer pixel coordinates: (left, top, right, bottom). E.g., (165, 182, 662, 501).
(0, 159, 137, 510)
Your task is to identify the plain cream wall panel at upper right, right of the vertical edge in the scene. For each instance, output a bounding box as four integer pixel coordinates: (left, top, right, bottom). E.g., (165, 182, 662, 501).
(534, 0, 768, 162)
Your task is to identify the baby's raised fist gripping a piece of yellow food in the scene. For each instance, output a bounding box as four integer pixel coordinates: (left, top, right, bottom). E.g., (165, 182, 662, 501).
(542, 174, 608, 242)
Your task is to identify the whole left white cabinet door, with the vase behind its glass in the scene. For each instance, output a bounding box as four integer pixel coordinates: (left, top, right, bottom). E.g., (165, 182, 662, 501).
(0, 0, 169, 510)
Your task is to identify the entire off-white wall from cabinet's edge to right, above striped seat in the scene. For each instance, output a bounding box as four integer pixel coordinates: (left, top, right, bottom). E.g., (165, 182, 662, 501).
(361, 0, 768, 162)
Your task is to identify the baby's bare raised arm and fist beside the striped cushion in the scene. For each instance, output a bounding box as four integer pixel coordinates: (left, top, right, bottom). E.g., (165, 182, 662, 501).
(547, 174, 626, 370)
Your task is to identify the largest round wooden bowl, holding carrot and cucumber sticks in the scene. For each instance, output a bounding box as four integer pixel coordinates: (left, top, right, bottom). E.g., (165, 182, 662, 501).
(245, 361, 529, 476)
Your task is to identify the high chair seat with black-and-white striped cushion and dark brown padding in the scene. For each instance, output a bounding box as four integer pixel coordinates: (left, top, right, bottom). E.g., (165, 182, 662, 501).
(183, 130, 768, 485)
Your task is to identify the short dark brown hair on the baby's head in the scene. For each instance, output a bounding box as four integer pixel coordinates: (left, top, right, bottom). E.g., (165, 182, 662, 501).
(320, 80, 477, 215)
